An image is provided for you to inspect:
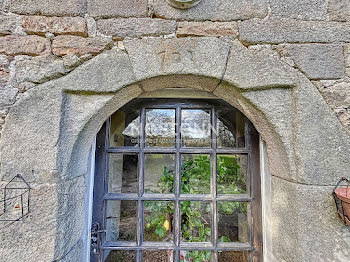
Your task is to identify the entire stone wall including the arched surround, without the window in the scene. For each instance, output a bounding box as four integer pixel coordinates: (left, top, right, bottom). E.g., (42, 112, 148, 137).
(0, 0, 350, 261)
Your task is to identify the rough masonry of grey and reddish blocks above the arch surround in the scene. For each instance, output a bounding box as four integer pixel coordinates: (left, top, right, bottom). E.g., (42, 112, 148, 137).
(0, 0, 350, 138)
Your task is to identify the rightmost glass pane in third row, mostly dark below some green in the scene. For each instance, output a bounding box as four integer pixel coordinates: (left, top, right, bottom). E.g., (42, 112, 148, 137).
(217, 201, 249, 242)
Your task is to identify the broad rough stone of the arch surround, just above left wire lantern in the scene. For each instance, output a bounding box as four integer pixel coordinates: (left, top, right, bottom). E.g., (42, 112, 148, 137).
(0, 81, 63, 182)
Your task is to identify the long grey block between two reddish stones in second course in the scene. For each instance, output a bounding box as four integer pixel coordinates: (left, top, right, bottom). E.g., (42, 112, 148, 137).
(97, 18, 176, 40)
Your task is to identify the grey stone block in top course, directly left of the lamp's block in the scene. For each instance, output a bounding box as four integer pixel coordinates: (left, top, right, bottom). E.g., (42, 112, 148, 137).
(87, 0, 147, 18)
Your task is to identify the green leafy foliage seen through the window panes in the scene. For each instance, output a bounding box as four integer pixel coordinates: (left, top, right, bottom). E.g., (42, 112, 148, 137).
(145, 155, 246, 262)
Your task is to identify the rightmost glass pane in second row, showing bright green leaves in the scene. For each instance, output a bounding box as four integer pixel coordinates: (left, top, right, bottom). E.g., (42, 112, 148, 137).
(216, 155, 248, 194)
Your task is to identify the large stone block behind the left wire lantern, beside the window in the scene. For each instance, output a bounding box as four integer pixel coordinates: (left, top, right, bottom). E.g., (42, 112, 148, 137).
(0, 177, 85, 262)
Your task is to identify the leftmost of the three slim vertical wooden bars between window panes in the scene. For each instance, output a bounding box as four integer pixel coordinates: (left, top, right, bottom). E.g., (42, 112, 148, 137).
(136, 107, 146, 262)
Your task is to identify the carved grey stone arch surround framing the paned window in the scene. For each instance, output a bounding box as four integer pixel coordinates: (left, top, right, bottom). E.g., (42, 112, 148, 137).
(1, 38, 350, 261)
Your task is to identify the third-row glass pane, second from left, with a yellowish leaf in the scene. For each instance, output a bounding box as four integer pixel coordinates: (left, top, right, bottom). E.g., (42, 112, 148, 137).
(143, 201, 174, 242)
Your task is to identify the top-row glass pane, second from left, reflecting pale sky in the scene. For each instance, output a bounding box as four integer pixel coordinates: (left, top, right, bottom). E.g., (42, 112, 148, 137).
(146, 109, 175, 147)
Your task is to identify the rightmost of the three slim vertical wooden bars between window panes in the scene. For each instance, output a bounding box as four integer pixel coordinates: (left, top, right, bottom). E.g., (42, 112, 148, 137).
(210, 107, 218, 262)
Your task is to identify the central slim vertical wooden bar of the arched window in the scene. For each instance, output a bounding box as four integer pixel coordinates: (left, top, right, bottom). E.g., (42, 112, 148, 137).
(174, 106, 181, 262)
